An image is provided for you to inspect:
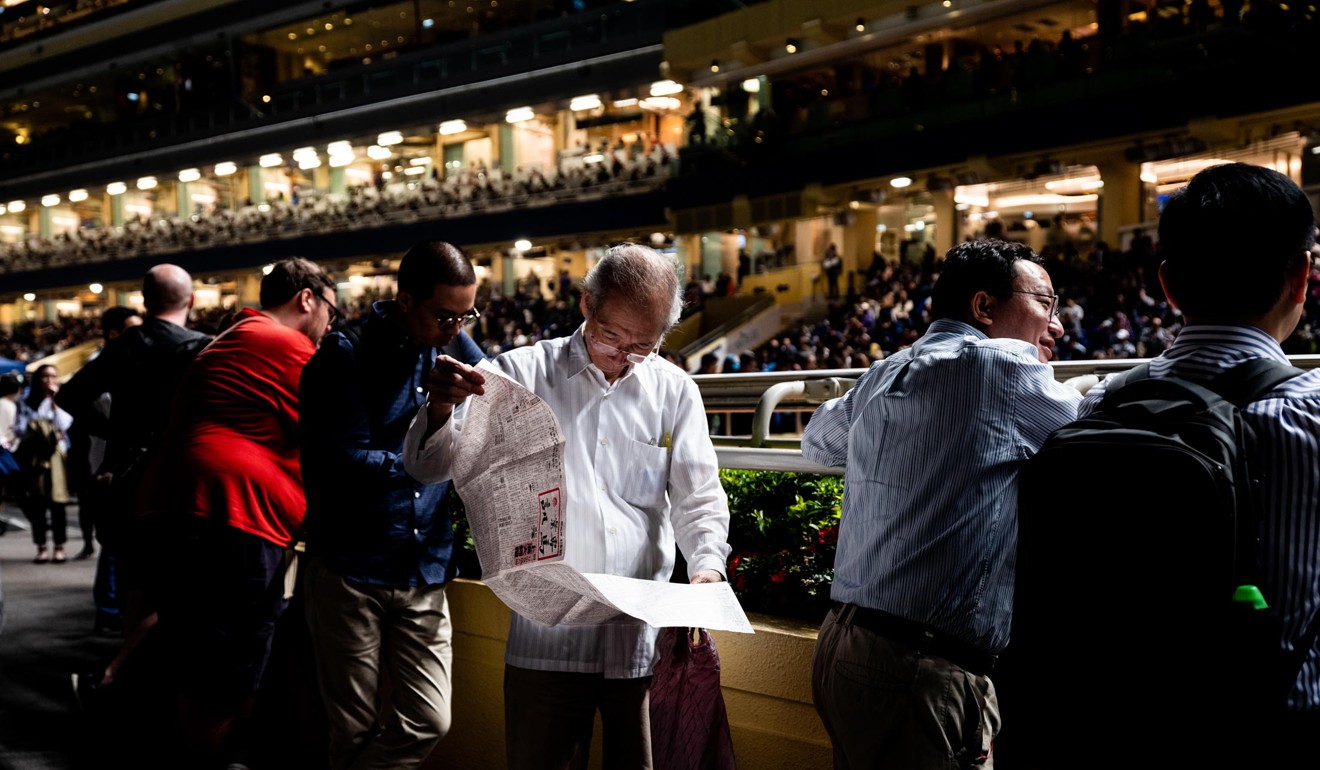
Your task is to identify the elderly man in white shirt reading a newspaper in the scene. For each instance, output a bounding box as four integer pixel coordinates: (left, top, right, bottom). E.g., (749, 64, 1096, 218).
(404, 243, 729, 770)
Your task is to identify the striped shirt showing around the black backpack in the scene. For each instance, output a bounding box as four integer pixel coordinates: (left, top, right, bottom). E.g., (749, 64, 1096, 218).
(1081, 324, 1320, 711)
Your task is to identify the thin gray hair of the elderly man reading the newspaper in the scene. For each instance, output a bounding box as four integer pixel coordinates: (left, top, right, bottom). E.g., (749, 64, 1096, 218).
(582, 243, 682, 330)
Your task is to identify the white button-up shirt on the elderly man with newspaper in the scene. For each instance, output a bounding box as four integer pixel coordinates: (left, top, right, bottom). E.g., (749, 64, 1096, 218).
(404, 328, 729, 679)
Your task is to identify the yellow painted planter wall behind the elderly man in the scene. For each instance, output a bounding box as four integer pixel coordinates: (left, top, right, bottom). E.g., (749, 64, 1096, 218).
(422, 580, 832, 770)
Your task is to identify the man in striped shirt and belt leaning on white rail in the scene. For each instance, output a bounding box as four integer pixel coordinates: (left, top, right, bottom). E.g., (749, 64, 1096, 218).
(803, 240, 1081, 769)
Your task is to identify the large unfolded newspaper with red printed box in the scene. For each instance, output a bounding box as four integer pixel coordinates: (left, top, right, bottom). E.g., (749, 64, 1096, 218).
(453, 363, 752, 634)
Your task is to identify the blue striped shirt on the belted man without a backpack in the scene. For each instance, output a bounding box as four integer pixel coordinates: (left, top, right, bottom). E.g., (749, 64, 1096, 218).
(803, 320, 1081, 652)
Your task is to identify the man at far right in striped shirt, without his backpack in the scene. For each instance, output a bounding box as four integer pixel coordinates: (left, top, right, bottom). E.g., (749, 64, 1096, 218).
(1081, 164, 1320, 766)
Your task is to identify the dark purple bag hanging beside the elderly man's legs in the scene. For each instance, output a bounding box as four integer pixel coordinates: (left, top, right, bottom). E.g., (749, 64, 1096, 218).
(651, 629, 735, 770)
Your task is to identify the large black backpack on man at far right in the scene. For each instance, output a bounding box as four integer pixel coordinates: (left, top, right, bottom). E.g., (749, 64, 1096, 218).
(997, 359, 1315, 765)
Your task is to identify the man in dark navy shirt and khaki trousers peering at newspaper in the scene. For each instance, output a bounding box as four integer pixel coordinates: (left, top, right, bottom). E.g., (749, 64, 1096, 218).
(298, 242, 482, 770)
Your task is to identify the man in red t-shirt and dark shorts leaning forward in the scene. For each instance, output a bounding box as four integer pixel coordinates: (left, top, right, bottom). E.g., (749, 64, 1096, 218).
(139, 259, 339, 767)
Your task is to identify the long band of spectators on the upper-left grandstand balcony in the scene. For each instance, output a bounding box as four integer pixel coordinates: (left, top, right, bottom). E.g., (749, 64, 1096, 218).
(0, 144, 675, 272)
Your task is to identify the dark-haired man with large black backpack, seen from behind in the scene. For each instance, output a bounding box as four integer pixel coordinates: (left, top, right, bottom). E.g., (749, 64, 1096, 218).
(1001, 164, 1320, 769)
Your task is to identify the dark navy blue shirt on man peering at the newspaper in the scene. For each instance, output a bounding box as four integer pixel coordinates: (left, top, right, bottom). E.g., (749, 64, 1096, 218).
(298, 301, 484, 588)
